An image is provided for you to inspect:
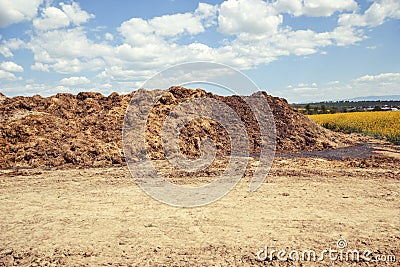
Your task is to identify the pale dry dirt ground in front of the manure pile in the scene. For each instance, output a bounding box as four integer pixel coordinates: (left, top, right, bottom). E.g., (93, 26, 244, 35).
(0, 143, 400, 266)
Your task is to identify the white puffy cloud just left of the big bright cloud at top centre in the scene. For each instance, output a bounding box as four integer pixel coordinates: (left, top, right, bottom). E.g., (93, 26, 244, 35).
(111, 3, 220, 73)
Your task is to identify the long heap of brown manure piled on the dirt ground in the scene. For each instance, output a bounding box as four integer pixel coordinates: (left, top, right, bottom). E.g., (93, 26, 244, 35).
(0, 87, 351, 169)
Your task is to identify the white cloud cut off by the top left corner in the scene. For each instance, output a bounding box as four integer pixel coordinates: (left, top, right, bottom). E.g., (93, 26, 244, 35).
(0, 0, 43, 28)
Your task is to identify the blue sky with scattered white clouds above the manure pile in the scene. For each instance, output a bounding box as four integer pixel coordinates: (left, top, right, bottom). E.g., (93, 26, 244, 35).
(0, 0, 400, 102)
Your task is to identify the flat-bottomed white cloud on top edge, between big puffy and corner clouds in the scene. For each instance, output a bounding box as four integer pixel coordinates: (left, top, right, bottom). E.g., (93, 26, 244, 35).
(274, 0, 358, 17)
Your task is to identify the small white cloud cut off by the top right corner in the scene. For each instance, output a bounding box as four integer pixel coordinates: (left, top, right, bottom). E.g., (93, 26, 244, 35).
(338, 0, 400, 27)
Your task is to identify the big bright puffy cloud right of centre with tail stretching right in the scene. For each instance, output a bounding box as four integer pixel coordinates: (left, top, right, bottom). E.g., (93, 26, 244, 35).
(215, 0, 364, 69)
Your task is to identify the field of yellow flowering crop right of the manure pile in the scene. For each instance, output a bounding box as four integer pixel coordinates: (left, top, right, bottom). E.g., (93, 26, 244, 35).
(308, 111, 400, 144)
